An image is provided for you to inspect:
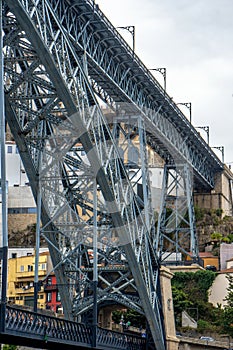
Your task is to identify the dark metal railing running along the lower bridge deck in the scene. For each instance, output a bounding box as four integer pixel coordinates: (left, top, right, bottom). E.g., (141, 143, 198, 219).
(1, 305, 146, 350)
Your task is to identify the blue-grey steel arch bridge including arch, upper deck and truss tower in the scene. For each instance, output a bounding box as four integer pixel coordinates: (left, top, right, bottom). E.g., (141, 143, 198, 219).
(3, 0, 223, 350)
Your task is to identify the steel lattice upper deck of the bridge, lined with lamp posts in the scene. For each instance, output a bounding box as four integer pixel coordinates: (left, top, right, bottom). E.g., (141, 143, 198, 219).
(43, 0, 223, 188)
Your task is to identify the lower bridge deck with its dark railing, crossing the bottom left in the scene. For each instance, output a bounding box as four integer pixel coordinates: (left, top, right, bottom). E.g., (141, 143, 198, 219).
(0, 306, 146, 350)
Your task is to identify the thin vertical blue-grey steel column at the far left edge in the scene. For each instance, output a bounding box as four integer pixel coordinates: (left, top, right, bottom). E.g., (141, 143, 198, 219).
(0, 0, 8, 332)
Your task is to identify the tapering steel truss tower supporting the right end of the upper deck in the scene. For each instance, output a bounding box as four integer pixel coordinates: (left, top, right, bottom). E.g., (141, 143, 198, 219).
(155, 164, 199, 264)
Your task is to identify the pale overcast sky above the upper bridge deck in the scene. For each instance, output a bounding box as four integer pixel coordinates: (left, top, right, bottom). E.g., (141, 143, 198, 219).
(96, 0, 233, 167)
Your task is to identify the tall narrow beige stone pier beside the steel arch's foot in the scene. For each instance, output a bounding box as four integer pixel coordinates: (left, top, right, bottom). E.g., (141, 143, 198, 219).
(160, 266, 179, 350)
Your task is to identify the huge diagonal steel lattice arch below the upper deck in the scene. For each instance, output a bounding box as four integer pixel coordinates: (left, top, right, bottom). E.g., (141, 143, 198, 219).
(4, 0, 165, 349)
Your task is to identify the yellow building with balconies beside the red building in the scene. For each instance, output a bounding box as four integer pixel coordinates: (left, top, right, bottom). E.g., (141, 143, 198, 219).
(7, 252, 52, 309)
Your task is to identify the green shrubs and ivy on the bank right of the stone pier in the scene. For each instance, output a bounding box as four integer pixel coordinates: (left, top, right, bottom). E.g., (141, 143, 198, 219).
(172, 271, 233, 337)
